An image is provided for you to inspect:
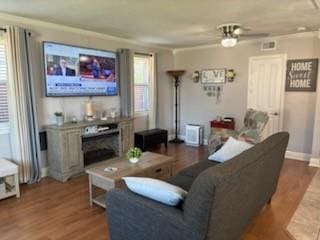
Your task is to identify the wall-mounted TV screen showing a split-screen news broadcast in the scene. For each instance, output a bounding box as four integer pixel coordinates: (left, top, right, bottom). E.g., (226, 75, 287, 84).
(43, 42, 118, 97)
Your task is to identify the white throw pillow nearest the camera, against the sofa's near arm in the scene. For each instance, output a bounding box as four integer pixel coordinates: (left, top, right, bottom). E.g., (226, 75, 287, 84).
(122, 177, 187, 206)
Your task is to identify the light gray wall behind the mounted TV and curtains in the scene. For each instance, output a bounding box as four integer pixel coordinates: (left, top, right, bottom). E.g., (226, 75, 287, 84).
(0, 16, 173, 167)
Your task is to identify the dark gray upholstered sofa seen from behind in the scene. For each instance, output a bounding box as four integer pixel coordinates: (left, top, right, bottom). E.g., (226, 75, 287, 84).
(106, 132, 289, 240)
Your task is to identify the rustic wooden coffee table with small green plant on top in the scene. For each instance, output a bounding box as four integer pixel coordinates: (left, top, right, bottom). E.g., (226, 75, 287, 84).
(86, 152, 174, 208)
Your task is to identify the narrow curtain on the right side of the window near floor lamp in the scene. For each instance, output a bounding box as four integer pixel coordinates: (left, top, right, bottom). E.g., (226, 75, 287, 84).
(148, 53, 158, 129)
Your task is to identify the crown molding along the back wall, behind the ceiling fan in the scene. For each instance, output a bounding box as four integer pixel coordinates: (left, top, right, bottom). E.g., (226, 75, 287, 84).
(172, 29, 320, 54)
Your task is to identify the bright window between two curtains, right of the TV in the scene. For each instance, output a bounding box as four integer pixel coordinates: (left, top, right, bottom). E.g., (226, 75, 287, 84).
(134, 55, 150, 113)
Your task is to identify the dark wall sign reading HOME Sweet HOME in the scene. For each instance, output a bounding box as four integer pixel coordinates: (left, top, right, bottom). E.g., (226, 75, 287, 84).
(286, 59, 319, 92)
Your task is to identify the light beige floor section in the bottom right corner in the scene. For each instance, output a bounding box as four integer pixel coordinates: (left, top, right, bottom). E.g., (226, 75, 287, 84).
(287, 171, 320, 240)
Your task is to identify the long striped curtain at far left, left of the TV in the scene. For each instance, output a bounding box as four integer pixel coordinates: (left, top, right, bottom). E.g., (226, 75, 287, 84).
(6, 26, 41, 183)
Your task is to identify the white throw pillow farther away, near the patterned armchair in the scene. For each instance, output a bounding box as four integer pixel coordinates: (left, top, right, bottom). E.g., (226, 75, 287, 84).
(208, 137, 253, 162)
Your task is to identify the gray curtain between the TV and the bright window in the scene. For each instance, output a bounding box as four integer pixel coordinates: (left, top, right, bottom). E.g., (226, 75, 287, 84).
(119, 49, 134, 117)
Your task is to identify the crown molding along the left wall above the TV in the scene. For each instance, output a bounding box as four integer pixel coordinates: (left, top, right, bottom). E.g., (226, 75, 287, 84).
(0, 12, 173, 51)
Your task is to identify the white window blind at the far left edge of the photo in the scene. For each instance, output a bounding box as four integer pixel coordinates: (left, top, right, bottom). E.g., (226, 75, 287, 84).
(0, 43, 9, 123)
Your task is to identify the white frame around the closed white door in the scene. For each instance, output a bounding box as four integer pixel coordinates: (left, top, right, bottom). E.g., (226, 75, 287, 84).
(247, 54, 288, 131)
